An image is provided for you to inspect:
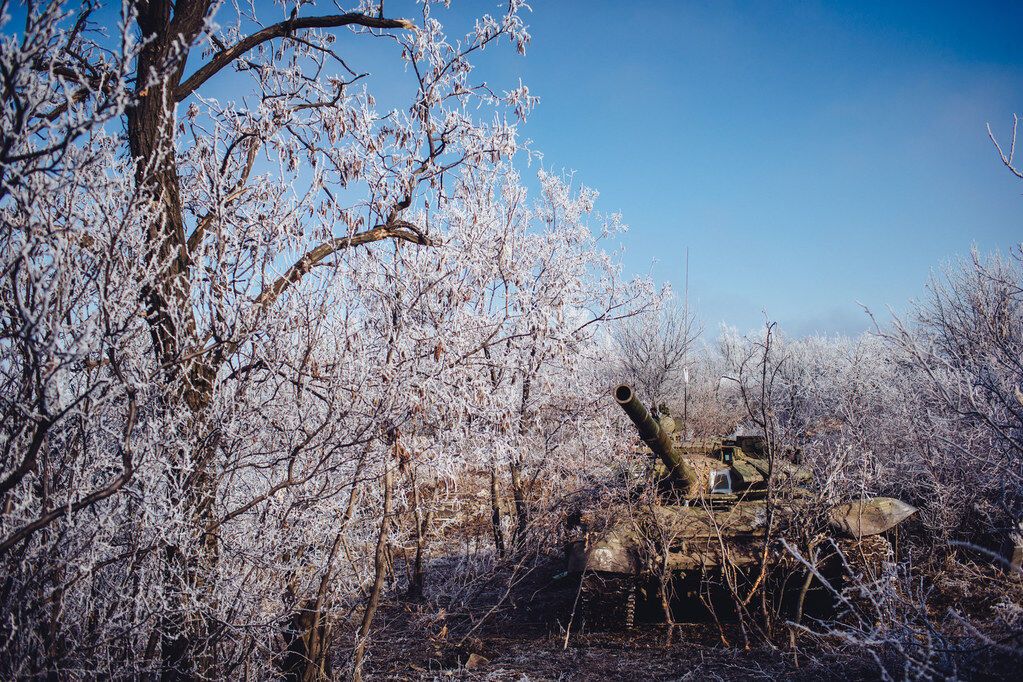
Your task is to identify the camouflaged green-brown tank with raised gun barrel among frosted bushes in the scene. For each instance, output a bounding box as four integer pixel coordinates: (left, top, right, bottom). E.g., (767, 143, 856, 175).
(565, 384, 917, 627)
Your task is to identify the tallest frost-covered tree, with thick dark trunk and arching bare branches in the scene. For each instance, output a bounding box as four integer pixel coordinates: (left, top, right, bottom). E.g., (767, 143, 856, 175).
(0, 0, 544, 676)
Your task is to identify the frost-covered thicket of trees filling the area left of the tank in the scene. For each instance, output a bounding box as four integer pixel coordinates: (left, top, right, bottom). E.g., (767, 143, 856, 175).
(0, 0, 653, 679)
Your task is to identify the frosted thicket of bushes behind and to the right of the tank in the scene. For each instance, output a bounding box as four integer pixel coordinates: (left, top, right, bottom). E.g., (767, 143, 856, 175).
(638, 247, 1023, 679)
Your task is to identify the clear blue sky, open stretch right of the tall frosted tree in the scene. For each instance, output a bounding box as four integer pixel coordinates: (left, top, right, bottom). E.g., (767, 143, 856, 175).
(491, 0, 1023, 335)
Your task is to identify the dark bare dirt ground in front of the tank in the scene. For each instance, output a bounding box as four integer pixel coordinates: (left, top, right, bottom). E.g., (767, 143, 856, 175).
(366, 572, 878, 682)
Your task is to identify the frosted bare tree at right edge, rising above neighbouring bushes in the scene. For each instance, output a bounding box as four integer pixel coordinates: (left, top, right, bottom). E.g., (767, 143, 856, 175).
(887, 247, 1023, 538)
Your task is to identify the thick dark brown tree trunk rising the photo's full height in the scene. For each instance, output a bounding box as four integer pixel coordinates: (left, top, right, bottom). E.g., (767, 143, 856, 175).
(126, 0, 217, 680)
